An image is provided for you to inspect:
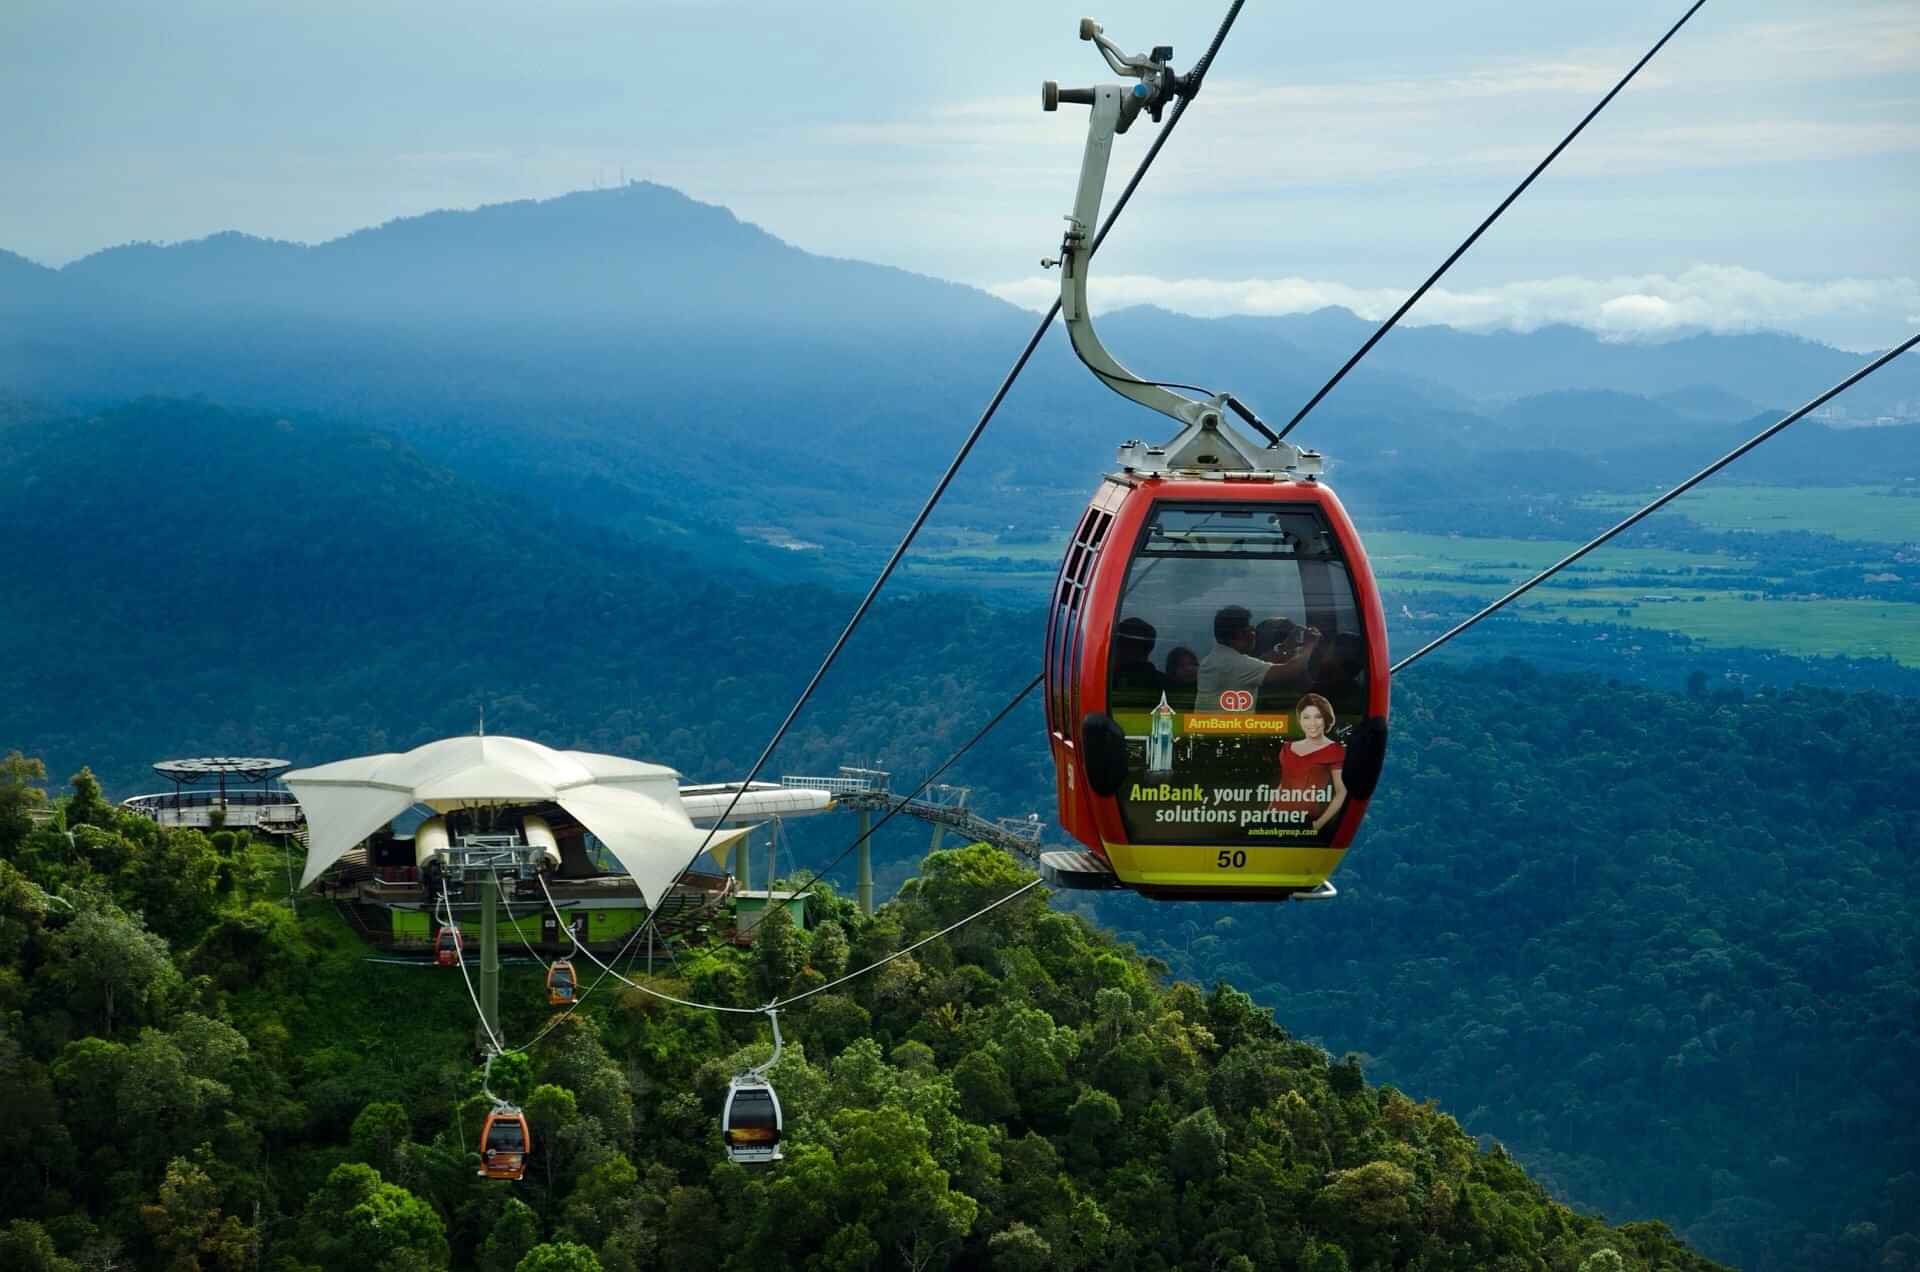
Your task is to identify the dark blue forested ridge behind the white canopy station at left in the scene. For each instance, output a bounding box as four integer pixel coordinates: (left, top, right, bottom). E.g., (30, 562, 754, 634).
(0, 400, 1044, 807)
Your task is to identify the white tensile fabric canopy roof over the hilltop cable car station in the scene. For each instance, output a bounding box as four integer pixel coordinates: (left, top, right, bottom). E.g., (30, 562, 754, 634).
(280, 738, 747, 909)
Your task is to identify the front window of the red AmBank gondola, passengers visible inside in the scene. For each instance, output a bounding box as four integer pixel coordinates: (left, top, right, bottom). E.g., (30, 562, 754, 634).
(1108, 503, 1367, 861)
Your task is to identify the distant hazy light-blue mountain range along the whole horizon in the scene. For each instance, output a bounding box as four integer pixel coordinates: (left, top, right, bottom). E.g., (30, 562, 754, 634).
(0, 183, 1920, 571)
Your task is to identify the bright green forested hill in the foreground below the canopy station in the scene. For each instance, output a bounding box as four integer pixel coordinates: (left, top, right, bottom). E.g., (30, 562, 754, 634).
(0, 753, 1716, 1272)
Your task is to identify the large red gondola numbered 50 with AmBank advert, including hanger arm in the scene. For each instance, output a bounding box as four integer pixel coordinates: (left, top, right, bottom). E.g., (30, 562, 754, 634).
(1041, 23, 1388, 899)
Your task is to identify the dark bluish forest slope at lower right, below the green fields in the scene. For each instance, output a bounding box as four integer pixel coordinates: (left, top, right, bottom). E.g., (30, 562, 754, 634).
(1087, 661, 1920, 1268)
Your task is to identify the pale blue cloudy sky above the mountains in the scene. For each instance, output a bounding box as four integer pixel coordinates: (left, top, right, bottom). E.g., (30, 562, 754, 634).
(0, 0, 1920, 350)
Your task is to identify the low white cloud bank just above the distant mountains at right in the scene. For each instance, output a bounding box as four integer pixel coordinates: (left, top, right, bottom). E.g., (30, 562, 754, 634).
(989, 265, 1920, 348)
